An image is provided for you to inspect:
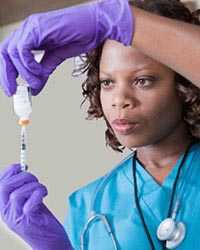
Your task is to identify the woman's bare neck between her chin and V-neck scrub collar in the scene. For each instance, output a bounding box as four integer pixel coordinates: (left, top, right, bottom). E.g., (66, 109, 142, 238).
(137, 123, 191, 169)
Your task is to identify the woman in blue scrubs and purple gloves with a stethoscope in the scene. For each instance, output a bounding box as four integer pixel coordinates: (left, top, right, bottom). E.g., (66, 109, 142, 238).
(0, 0, 200, 250)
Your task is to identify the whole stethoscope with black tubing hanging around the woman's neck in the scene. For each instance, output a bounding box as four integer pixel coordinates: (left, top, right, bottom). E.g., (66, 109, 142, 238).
(80, 142, 194, 250)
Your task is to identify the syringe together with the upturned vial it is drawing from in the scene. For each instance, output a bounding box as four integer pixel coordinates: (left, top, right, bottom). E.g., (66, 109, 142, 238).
(13, 84, 32, 171)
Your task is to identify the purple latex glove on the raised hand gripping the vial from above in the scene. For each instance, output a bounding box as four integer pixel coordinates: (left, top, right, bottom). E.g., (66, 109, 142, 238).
(0, 0, 134, 96)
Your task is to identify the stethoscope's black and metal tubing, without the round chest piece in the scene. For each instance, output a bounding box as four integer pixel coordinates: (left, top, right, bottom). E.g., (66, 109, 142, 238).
(80, 143, 197, 250)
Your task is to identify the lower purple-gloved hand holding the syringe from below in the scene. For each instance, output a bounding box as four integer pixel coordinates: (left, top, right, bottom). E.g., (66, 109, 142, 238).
(0, 164, 72, 250)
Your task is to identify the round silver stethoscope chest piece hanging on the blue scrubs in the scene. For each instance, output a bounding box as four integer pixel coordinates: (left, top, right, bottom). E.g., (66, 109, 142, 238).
(157, 218, 186, 249)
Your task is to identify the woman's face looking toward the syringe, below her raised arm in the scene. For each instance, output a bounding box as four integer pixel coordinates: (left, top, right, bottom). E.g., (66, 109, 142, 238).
(99, 40, 183, 148)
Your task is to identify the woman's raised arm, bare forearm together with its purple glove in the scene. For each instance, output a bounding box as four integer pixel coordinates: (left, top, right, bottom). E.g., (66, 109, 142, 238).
(0, 0, 200, 96)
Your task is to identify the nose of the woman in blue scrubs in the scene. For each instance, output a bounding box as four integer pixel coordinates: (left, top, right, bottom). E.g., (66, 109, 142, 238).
(112, 89, 137, 109)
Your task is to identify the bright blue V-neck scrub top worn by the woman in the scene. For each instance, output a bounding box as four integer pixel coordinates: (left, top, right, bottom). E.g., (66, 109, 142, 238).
(64, 142, 200, 250)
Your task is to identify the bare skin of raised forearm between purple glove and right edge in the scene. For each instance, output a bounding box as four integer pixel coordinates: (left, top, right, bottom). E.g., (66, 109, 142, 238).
(131, 6, 200, 88)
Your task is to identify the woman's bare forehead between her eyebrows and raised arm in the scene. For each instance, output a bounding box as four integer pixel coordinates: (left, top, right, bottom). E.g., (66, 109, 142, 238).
(100, 40, 161, 72)
